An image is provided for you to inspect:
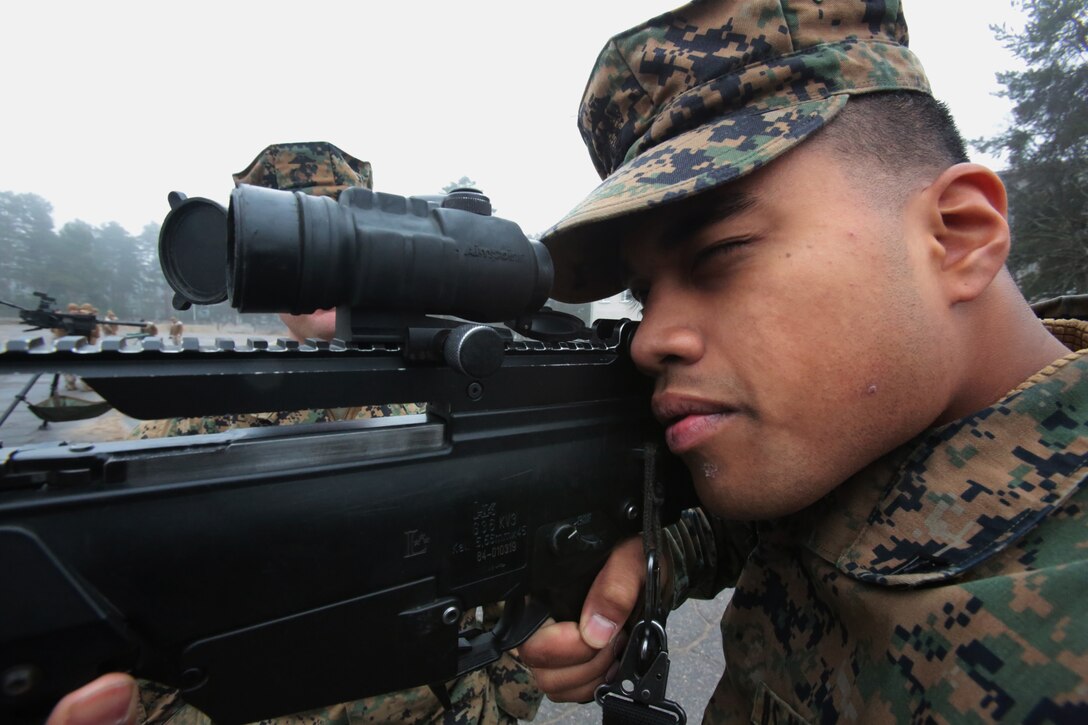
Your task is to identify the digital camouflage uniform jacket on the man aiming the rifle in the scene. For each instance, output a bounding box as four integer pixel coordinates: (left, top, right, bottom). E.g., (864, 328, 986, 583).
(670, 320, 1088, 723)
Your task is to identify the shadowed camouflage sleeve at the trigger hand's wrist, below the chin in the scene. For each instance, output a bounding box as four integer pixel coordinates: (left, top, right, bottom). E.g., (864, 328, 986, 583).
(665, 507, 755, 609)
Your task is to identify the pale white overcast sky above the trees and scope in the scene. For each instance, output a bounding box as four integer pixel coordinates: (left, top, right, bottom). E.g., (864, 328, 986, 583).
(0, 0, 1022, 234)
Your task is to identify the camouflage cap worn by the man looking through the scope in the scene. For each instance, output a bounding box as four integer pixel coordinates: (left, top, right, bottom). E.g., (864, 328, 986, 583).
(543, 0, 930, 302)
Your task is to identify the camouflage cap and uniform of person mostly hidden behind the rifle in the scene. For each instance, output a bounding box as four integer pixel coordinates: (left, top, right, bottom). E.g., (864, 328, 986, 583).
(133, 142, 543, 725)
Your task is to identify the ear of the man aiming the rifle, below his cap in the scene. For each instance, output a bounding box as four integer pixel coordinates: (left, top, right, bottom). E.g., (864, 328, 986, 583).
(919, 163, 1010, 304)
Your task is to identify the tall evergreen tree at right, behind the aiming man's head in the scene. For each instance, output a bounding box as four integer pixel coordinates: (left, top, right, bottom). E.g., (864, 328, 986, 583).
(975, 0, 1088, 300)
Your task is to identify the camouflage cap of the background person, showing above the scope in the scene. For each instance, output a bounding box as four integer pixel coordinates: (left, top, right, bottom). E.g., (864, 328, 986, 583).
(234, 142, 373, 198)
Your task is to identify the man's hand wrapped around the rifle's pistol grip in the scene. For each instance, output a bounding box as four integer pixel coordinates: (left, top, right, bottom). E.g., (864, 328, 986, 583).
(520, 539, 646, 701)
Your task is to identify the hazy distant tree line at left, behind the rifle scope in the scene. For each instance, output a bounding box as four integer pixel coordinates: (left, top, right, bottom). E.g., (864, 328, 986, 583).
(0, 192, 267, 324)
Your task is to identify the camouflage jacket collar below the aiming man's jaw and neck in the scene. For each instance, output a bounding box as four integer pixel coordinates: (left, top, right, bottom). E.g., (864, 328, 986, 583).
(801, 320, 1088, 586)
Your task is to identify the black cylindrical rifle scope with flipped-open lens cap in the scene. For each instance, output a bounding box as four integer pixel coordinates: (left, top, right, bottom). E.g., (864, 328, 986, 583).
(159, 185, 554, 322)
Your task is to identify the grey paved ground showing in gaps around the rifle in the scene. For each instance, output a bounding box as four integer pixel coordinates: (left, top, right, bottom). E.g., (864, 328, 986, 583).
(0, 324, 732, 725)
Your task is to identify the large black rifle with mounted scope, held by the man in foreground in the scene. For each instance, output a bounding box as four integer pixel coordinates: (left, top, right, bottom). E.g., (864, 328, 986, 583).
(0, 187, 692, 723)
